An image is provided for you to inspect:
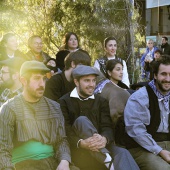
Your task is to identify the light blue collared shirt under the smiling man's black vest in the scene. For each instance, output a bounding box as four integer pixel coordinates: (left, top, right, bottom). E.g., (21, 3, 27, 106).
(124, 87, 169, 154)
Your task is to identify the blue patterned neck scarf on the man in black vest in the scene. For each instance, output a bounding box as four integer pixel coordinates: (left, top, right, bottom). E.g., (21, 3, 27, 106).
(149, 80, 170, 110)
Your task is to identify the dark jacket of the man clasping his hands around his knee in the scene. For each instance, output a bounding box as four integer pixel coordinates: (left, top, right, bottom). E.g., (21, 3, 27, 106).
(59, 93, 113, 147)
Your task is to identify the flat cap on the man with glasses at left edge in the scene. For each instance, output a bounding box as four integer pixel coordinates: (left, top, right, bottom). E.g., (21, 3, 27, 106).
(0, 57, 26, 71)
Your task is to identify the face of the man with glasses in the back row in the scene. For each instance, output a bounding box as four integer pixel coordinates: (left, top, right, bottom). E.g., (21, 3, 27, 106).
(30, 37, 43, 54)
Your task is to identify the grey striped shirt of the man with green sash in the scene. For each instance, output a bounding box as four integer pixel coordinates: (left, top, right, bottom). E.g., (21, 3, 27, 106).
(0, 94, 71, 169)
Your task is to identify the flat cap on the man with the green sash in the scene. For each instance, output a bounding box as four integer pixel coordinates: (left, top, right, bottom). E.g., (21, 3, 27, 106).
(20, 60, 50, 76)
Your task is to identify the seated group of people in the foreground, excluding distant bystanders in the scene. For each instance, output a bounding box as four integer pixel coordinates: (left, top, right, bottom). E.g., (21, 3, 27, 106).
(0, 32, 170, 170)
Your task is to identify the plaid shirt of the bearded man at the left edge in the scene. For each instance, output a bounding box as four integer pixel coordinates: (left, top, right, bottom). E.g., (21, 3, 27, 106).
(0, 87, 23, 107)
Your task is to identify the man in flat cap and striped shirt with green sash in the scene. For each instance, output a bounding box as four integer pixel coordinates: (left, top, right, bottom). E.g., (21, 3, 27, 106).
(0, 61, 78, 170)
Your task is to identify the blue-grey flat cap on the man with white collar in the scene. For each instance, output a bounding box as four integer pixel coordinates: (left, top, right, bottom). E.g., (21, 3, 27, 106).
(72, 65, 99, 78)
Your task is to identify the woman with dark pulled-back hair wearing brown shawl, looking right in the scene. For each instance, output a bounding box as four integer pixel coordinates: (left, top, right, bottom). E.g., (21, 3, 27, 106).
(94, 59, 130, 133)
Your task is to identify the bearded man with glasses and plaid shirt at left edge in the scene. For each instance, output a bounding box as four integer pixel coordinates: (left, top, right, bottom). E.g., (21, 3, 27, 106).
(0, 57, 25, 106)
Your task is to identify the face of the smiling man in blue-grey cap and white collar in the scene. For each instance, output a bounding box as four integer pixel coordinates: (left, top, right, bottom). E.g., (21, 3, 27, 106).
(74, 75, 96, 98)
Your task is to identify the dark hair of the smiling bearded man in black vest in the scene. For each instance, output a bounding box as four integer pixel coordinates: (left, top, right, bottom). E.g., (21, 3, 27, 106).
(153, 55, 170, 75)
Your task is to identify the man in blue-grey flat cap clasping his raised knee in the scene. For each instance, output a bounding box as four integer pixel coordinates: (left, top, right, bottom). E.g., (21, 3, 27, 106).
(59, 65, 139, 170)
